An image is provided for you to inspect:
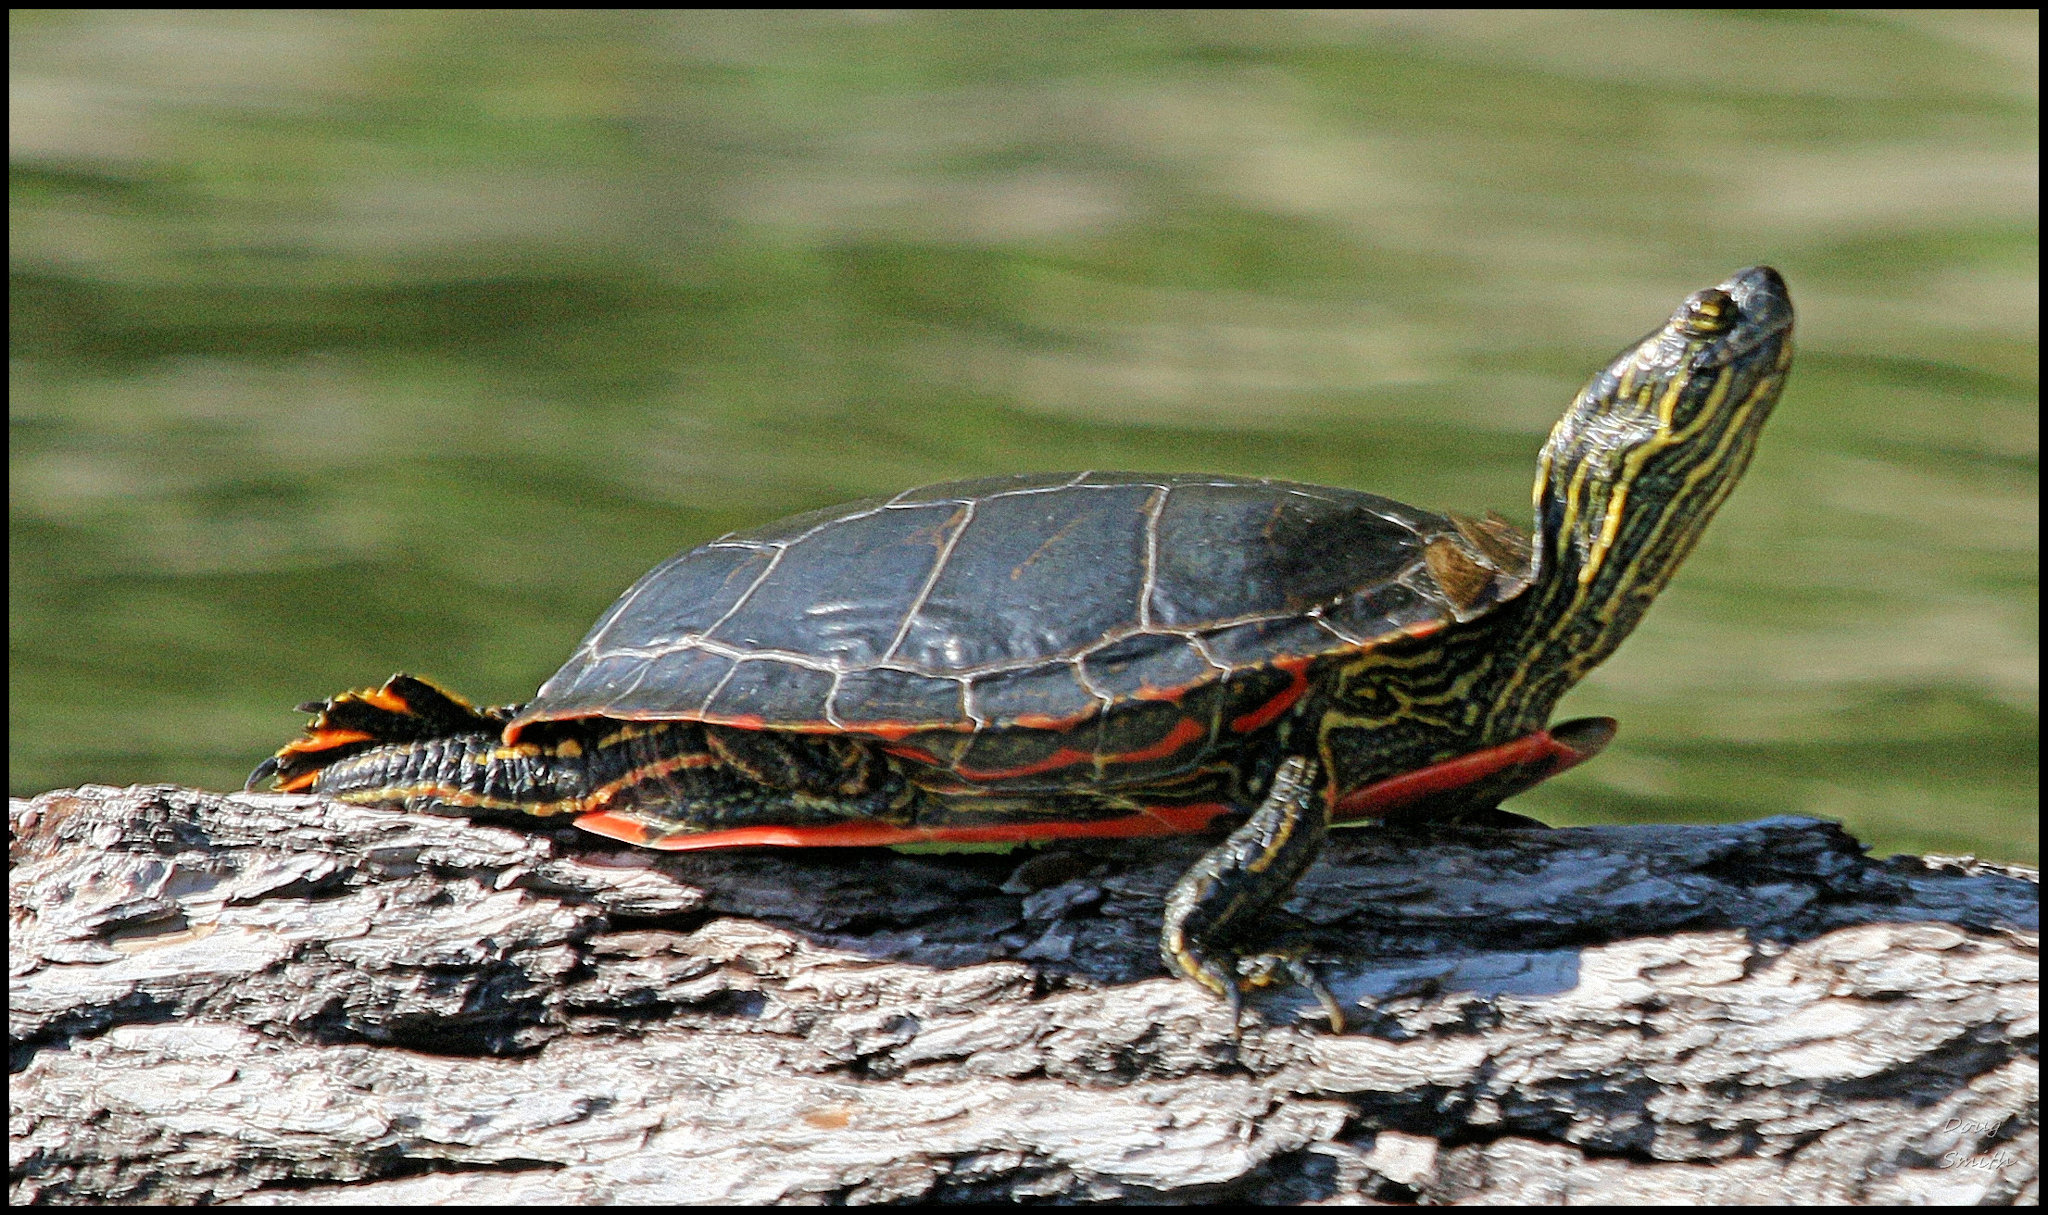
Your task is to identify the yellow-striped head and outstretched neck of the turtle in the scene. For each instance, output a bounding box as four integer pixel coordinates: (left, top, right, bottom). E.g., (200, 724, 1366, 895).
(1507, 266, 1792, 725)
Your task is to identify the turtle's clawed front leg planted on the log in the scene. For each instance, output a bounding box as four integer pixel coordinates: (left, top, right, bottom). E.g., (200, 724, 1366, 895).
(1159, 756, 1343, 1033)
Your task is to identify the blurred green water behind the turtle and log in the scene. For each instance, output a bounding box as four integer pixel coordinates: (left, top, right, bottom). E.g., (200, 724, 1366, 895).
(8, 10, 2040, 858)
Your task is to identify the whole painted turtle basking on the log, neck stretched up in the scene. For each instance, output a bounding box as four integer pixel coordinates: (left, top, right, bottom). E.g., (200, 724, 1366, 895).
(248, 266, 1792, 1033)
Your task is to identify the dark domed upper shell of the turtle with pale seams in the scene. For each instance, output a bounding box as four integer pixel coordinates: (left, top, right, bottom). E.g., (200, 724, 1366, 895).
(506, 471, 1530, 762)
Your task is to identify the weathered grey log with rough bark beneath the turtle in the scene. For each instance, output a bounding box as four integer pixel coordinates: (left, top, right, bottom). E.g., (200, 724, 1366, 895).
(8, 787, 2040, 1205)
